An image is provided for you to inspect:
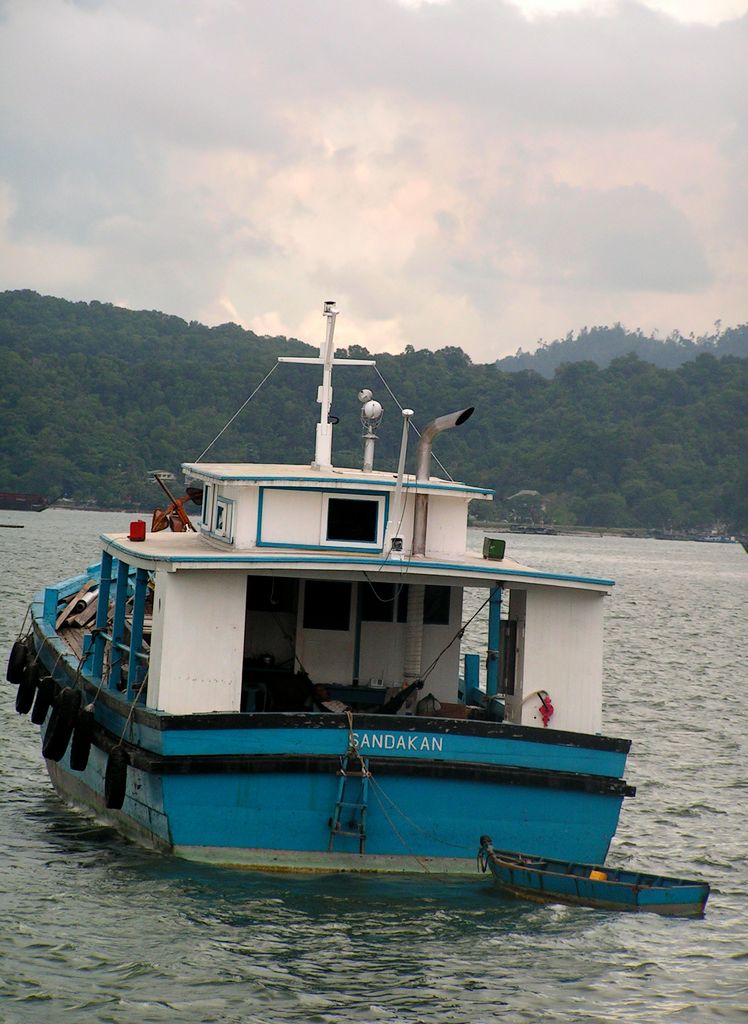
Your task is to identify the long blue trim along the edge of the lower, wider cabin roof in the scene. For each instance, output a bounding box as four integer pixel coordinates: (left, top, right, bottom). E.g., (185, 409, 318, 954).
(102, 534, 616, 587)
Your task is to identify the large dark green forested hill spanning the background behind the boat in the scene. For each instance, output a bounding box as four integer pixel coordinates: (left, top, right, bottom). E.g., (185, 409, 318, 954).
(0, 291, 748, 531)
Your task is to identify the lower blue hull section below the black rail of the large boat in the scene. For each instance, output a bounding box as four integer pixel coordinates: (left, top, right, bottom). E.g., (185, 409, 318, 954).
(48, 733, 623, 872)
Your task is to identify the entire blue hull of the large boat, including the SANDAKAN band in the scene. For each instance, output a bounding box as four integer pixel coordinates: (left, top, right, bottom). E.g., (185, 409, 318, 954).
(23, 585, 633, 873)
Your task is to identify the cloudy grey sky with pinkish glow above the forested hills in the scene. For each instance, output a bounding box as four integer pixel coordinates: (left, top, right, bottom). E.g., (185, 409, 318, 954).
(0, 0, 748, 361)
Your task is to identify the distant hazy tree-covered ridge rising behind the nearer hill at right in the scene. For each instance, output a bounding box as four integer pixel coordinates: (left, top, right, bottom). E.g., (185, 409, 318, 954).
(496, 324, 748, 378)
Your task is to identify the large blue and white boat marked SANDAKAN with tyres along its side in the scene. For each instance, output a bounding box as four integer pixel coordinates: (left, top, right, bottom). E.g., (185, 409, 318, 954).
(7, 303, 633, 874)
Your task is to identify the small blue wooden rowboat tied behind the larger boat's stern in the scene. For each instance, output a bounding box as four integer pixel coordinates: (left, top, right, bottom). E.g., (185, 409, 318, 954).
(477, 836, 709, 916)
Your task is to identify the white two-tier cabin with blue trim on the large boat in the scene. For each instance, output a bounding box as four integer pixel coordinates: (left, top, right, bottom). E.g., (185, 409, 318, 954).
(100, 456, 611, 732)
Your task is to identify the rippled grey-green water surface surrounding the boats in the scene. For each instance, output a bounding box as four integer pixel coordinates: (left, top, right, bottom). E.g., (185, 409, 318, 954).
(0, 510, 748, 1024)
